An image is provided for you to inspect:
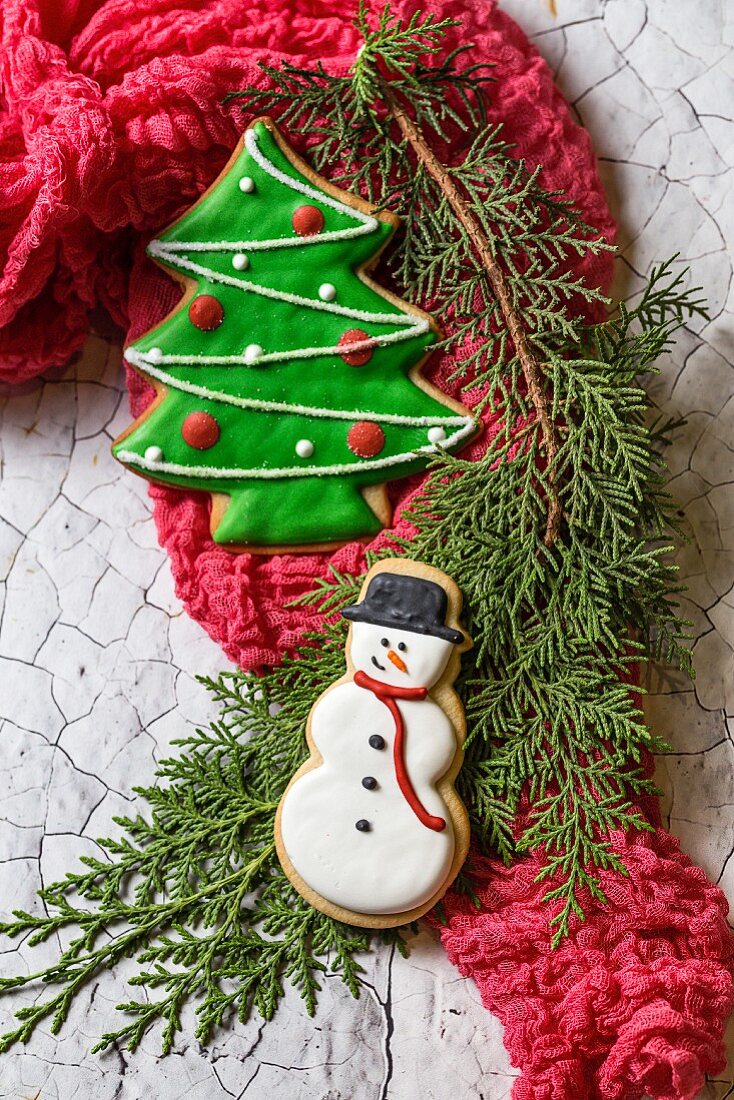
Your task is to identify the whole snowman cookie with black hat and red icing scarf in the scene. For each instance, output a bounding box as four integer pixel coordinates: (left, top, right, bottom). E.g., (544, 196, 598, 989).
(275, 559, 471, 927)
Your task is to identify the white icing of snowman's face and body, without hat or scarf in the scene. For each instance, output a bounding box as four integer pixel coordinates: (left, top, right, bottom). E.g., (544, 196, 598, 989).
(280, 623, 459, 915)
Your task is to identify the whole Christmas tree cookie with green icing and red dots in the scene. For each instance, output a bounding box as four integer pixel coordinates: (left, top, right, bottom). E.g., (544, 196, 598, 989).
(113, 119, 475, 550)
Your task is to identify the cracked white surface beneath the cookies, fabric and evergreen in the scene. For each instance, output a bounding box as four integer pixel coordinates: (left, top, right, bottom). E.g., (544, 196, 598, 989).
(0, 0, 734, 1100)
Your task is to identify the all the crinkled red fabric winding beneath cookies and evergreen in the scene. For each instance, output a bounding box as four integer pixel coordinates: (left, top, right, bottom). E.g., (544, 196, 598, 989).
(0, 0, 733, 1100)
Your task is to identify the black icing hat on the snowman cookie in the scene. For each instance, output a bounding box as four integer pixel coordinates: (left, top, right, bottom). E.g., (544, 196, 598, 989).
(341, 573, 464, 646)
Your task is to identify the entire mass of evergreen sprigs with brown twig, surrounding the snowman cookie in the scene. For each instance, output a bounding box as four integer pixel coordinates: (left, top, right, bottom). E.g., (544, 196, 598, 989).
(0, 6, 703, 1051)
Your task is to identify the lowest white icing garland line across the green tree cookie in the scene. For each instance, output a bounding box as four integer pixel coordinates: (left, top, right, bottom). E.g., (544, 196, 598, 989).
(117, 416, 474, 481)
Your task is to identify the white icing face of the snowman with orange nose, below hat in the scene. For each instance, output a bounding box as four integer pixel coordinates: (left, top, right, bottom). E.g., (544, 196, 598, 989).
(350, 623, 453, 688)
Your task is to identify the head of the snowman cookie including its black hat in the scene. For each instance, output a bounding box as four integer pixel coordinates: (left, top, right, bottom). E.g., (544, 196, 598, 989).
(342, 571, 464, 688)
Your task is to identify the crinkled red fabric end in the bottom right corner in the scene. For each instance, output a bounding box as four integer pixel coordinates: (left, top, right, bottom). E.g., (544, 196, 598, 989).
(441, 828, 732, 1100)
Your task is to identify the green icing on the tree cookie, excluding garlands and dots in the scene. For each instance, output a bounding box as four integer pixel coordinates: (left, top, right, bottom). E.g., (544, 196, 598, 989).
(113, 123, 473, 546)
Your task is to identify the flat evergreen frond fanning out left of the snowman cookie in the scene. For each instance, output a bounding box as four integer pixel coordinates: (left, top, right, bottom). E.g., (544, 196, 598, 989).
(0, 631, 405, 1053)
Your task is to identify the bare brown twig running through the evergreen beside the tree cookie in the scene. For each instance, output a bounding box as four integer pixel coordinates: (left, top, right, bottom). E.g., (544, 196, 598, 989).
(383, 83, 563, 547)
